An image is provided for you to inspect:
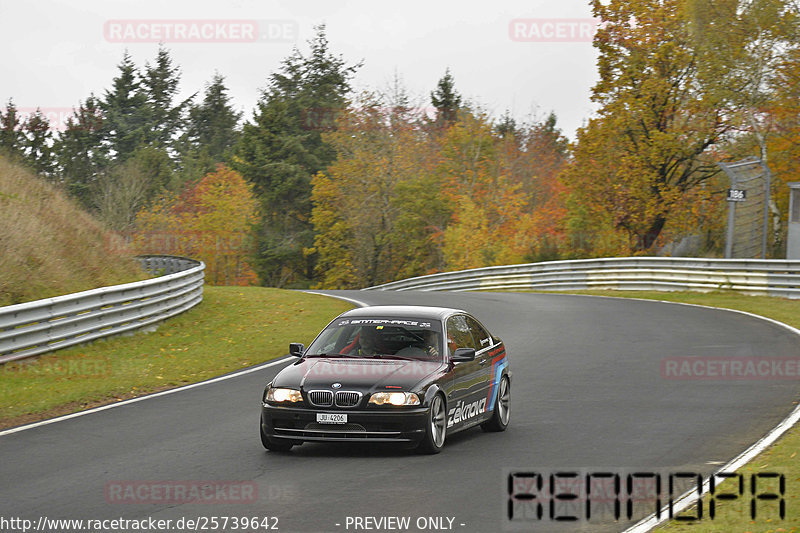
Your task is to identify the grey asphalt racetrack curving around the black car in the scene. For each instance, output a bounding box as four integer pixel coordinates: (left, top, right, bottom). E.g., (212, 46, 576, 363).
(0, 291, 800, 532)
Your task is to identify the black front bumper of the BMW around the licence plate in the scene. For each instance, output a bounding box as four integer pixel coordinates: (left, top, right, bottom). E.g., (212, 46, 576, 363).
(261, 405, 428, 442)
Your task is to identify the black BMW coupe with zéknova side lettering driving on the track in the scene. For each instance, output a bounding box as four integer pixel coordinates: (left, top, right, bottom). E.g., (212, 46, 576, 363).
(261, 306, 511, 453)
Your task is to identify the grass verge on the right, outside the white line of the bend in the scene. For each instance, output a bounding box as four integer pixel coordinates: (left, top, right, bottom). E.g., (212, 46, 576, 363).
(536, 291, 800, 533)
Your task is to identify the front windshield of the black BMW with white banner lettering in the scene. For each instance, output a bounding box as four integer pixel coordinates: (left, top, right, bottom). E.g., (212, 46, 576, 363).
(306, 317, 442, 361)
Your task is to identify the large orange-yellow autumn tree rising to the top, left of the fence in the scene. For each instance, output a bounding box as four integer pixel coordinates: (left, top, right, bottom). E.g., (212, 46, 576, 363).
(564, 0, 731, 254)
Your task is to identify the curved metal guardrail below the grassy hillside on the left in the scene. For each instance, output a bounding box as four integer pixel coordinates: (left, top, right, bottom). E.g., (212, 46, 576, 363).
(0, 256, 205, 364)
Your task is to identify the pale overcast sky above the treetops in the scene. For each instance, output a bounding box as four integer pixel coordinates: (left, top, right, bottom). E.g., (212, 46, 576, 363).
(0, 0, 597, 138)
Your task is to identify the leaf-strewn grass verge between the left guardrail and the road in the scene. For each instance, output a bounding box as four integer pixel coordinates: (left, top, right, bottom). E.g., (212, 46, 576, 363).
(0, 286, 352, 428)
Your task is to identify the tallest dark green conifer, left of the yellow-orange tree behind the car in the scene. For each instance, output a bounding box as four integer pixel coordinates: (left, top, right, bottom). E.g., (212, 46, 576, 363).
(233, 26, 360, 286)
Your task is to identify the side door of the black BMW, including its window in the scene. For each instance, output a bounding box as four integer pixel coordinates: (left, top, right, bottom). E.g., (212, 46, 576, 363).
(445, 315, 486, 429)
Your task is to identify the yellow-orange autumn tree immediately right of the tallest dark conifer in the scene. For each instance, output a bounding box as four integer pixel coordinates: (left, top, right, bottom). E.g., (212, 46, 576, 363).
(312, 93, 449, 288)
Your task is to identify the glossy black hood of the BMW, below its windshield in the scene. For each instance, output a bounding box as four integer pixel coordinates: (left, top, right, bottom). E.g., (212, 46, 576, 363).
(273, 358, 443, 392)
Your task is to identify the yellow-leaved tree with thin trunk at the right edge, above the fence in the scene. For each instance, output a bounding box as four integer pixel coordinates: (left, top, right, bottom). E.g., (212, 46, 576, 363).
(689, 0, 800, 248)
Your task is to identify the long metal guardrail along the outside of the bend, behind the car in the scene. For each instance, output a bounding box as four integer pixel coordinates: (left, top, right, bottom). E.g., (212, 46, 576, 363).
(363, 257, 800, 298)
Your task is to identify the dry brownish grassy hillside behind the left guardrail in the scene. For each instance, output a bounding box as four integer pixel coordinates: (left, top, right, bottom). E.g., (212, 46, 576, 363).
(0, 156, 145, 306)
